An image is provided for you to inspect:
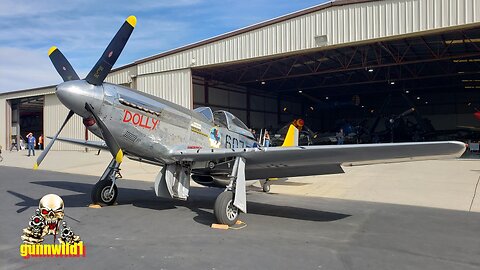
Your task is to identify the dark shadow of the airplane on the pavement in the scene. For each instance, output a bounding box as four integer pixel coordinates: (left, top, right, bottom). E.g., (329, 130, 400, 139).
(7, 181, 350, 226)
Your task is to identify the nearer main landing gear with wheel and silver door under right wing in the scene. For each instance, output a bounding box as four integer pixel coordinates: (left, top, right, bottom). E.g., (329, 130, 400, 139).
(214, 157, 247, 226)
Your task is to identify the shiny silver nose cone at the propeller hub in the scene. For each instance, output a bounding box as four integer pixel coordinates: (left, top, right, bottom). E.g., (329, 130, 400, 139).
(55, 80, 103, 117)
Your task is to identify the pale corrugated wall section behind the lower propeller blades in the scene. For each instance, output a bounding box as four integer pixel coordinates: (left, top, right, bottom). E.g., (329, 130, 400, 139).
(43, 95, 100, 150)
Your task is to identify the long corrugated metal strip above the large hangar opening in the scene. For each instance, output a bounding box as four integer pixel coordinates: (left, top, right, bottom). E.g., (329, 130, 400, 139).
(138, 0, 480, 75)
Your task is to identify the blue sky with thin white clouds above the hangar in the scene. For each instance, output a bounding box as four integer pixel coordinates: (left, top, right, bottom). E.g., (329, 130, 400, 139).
(0, 0, 326, 92)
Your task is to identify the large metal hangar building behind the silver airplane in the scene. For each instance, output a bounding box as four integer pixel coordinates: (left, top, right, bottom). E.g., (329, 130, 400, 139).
(0, 0, 480, 150)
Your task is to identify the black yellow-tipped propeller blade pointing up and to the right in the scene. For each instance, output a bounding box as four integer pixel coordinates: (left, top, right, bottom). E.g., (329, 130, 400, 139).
(85, 16, 137, 85)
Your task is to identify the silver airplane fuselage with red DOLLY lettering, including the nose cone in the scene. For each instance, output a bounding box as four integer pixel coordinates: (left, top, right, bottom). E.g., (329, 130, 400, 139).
(57, 80, 257, 174)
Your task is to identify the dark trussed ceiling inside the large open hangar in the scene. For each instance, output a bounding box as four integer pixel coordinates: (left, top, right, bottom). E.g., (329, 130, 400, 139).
(193, 27, 480, 95)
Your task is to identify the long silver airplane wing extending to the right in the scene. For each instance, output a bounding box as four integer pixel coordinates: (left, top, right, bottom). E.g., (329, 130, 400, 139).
(172, 141, 466, 179)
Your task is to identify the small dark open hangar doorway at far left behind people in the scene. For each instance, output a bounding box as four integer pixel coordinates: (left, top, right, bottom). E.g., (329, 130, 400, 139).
(7, 95, 45, 150)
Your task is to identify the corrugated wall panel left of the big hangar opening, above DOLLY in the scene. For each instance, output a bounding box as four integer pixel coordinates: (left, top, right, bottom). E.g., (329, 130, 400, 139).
(137, 69, 193, 109)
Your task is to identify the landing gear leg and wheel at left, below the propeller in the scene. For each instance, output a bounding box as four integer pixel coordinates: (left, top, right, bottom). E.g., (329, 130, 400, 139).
(91, 159, 122, 205)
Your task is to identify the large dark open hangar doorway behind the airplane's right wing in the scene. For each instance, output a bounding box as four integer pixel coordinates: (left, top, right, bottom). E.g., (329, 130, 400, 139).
(193, 27, 480, 143)
